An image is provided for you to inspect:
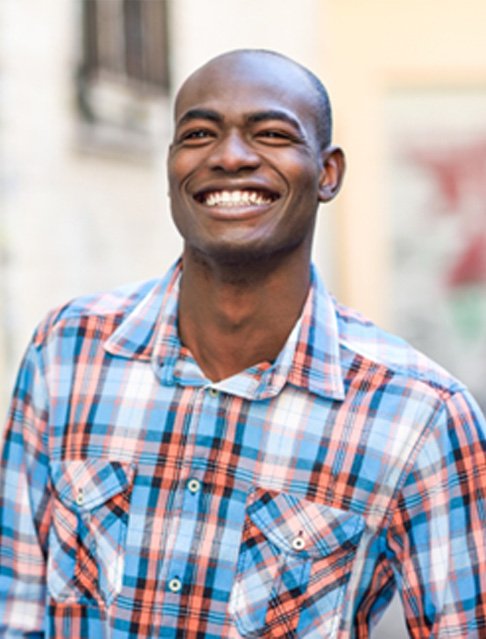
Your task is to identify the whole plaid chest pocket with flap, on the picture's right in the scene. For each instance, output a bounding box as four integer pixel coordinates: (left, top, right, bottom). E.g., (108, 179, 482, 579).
(230, 488, 364, 638)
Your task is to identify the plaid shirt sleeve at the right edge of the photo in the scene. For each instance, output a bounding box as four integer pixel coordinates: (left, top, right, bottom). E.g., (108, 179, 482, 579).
(388, 391, 486, 639)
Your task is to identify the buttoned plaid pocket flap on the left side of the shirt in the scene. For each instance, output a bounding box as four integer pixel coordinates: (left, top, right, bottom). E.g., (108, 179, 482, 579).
(51, 459, 135, 511)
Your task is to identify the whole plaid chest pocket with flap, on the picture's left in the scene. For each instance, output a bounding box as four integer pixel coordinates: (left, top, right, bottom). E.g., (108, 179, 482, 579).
(47, 459, 134, 606)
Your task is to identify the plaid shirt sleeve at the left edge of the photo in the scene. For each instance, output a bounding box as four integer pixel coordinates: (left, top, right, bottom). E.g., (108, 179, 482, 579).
(0, 344, 50, 639)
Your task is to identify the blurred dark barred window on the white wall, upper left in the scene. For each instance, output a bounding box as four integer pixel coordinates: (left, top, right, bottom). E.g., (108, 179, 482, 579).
(77, 0, 169, 155)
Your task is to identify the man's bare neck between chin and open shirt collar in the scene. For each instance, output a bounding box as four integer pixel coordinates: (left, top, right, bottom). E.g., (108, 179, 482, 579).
(178, 248, 310, 381)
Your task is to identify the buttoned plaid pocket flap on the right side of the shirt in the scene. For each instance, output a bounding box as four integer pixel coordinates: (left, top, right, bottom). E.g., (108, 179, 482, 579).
(248, 488, 365, 558)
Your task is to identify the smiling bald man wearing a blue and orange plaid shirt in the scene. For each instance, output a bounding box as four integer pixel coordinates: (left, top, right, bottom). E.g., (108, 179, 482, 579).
(0, 51, 486, 639)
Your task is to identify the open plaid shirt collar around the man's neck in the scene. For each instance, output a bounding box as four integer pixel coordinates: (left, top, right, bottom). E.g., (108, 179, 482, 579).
(104, 260, 344, 400)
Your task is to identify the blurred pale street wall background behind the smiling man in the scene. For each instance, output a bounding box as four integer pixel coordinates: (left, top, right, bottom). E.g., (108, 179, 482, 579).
(0, 0, 486, 639)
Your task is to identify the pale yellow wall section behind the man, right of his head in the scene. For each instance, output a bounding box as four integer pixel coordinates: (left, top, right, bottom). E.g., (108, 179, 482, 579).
(319, 0, 486, 324)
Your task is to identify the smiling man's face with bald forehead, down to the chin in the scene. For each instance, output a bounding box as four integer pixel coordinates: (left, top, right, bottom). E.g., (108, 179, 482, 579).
(168, 54, 344, 263)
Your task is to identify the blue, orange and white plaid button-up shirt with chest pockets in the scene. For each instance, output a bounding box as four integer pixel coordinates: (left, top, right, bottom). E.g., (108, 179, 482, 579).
(0, 266, 486, 639)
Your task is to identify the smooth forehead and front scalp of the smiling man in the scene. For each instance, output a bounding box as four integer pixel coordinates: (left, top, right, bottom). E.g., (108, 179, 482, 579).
(175, 54, 318, 127)
